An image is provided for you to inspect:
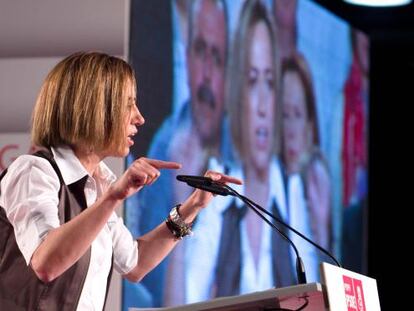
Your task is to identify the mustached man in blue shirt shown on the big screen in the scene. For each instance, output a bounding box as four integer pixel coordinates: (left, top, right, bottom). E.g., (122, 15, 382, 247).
(127, 0, 230, 306)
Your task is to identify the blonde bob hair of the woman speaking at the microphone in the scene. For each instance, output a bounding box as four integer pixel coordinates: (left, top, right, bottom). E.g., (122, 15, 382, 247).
(32, 52, 136, 155)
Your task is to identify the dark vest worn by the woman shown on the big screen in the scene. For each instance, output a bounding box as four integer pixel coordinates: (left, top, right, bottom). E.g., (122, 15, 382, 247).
(215, 201, 296, 297)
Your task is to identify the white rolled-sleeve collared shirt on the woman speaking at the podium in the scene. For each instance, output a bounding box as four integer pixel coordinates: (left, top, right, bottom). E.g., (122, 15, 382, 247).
(0, 147, 138, 310)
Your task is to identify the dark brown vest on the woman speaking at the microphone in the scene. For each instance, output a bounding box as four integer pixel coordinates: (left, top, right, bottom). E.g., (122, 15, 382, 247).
(0, 150, 112, 311)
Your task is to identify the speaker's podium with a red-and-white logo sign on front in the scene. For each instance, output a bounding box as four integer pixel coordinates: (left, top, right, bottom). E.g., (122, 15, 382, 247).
(129, 263, 381, 311)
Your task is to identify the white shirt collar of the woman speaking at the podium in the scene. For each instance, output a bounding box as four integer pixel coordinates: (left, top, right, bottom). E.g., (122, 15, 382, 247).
(52, 146, 116, 185)
